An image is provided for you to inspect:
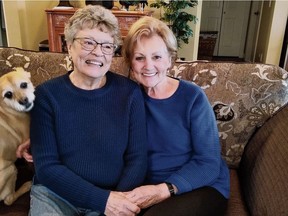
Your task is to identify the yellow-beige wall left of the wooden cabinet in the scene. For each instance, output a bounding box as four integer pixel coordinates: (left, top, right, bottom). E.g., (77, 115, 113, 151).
(3, 0, 58, 50)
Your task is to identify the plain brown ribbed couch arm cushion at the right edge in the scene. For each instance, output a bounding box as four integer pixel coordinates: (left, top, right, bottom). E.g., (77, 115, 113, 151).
(240, 105, 288, 216)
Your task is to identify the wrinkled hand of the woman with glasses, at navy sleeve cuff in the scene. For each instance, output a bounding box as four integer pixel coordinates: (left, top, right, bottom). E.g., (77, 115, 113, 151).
(105, 191, 141, 216)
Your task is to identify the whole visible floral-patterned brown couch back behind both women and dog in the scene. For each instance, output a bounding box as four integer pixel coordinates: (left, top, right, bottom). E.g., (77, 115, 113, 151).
(0, 48, 288, 168)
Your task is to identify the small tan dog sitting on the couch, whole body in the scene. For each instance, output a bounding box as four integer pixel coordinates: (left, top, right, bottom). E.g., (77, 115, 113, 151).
(0, 68, 35, 205)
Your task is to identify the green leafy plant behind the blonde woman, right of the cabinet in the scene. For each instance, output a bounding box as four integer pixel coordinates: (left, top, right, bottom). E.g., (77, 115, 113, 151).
(150, 0, 198, 47)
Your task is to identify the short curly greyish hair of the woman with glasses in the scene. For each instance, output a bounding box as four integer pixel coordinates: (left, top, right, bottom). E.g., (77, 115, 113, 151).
(64, 5, 121, 46)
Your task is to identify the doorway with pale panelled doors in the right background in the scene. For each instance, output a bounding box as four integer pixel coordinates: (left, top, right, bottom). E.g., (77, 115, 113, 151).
(200, 0, 262, 62)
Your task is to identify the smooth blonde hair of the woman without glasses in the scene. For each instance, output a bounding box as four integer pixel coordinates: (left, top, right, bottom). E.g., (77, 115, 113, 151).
(122, 16, 178, 68)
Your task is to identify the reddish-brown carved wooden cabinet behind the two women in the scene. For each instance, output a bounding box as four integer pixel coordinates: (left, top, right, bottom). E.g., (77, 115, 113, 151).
(45, 8, 152, 52)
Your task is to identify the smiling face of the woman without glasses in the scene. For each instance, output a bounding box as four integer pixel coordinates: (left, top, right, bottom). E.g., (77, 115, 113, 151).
(131, 35, 171, 88)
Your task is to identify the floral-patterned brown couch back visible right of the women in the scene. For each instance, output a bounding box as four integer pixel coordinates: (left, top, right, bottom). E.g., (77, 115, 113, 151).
(170, 61, 288, 168)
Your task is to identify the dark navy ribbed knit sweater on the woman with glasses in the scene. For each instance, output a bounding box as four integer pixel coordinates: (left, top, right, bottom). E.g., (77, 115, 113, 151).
(31, 72, 147, 212)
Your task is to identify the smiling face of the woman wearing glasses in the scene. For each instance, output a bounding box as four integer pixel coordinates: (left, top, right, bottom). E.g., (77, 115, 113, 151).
(67, 26, 114, 84)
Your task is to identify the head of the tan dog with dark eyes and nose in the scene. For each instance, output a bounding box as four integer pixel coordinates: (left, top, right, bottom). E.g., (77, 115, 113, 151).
(0, 68, 35, 112)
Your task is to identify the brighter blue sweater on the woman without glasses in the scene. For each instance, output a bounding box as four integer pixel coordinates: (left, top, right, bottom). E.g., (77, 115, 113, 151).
(143, 80, 230, 198)
